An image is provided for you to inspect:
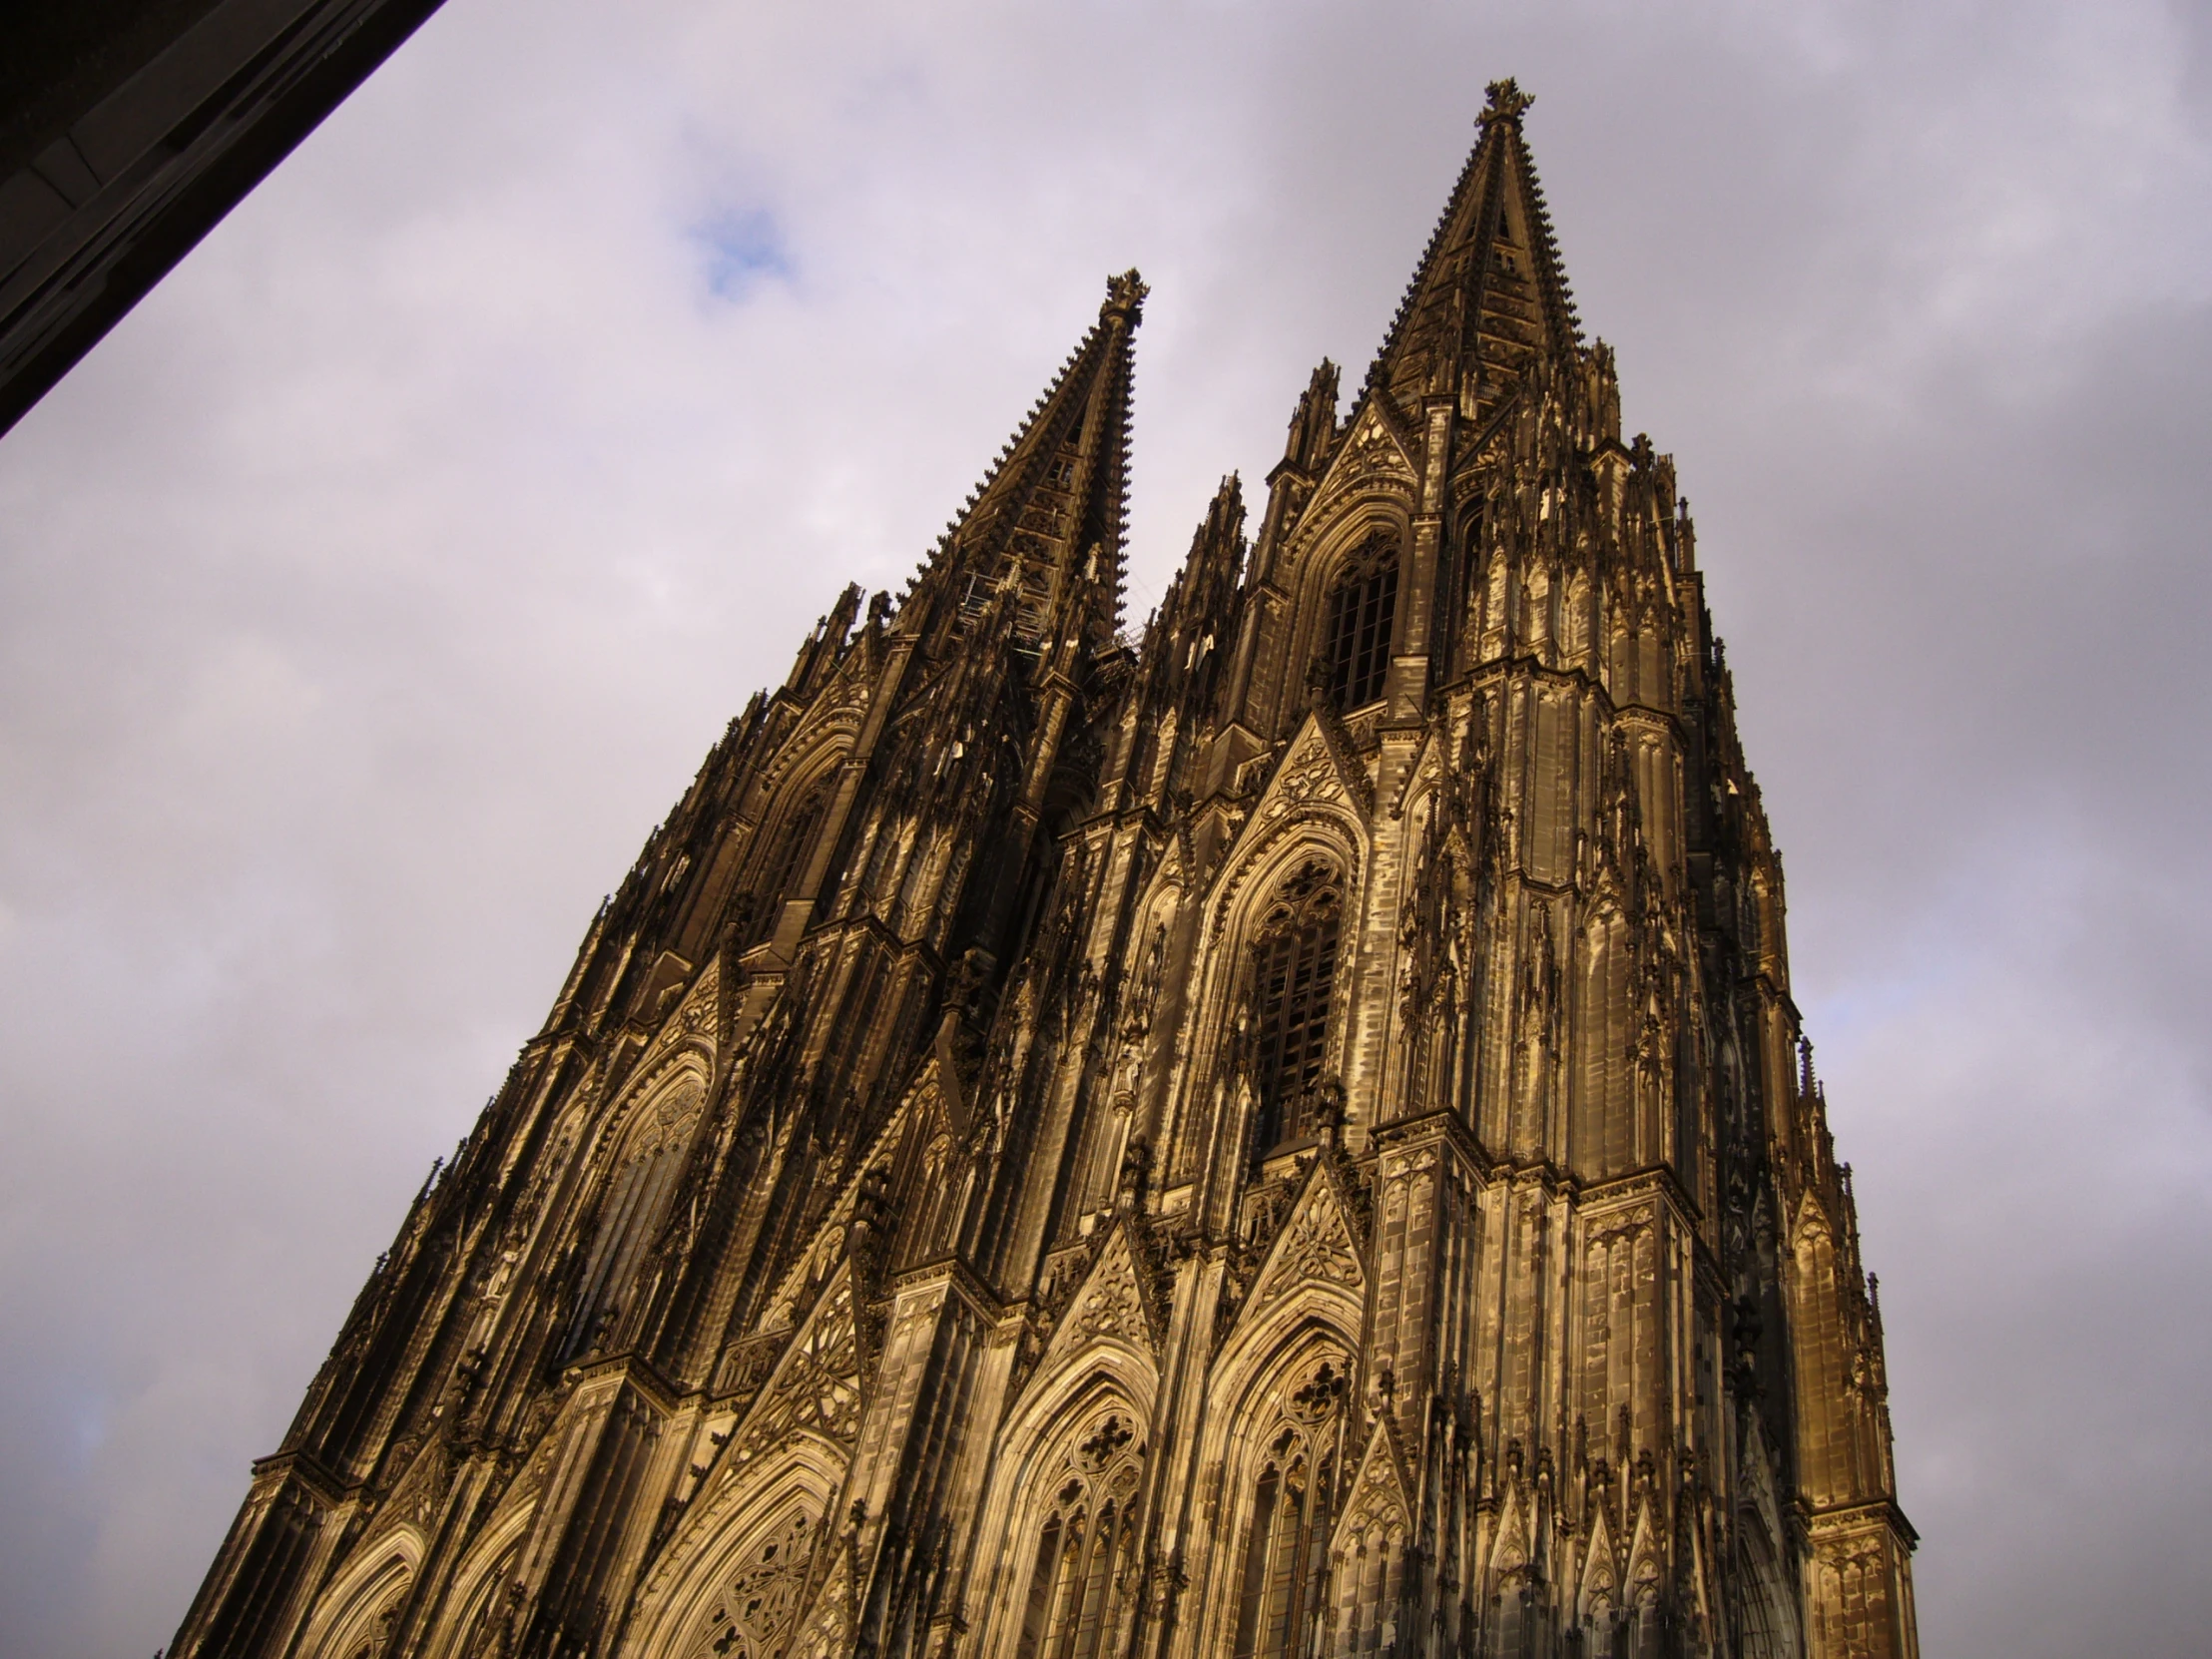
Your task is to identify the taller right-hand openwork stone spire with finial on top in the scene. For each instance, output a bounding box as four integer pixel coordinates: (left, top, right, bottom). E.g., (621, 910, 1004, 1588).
(1367, 80, 1581, 418)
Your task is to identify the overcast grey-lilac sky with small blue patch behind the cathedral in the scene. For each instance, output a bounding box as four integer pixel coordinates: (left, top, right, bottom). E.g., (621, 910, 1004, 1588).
(0, 0, 2212, 1659)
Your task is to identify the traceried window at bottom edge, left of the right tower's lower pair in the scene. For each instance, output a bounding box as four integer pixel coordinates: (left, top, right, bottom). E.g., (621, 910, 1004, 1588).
(1013, 1411, 1144, 1659)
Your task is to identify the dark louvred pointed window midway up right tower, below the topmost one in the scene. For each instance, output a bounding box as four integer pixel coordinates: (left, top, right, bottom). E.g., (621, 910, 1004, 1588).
(1252, 862, 1343, 1153)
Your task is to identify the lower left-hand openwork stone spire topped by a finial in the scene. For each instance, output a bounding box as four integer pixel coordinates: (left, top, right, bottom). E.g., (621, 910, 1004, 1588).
(902, 270, 1148, 646)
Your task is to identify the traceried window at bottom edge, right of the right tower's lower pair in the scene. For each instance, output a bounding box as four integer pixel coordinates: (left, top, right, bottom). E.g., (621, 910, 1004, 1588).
(1230, 1361, 1343, 1659)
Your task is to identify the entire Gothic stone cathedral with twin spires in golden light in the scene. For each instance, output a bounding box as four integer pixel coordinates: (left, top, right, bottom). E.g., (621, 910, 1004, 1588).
(173, 82, 1916, 1659)
